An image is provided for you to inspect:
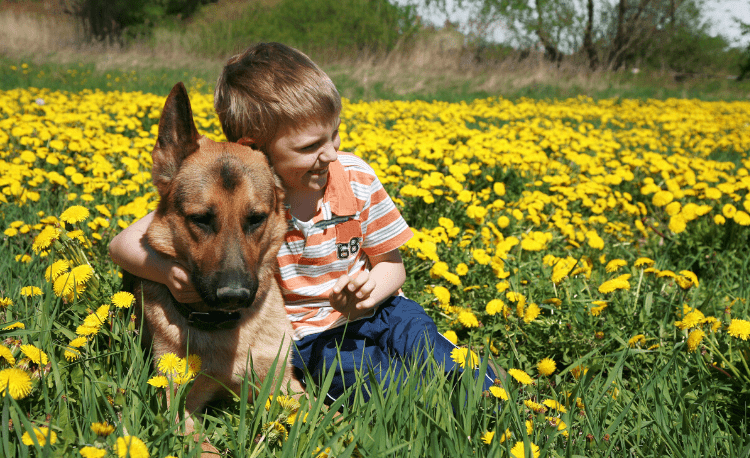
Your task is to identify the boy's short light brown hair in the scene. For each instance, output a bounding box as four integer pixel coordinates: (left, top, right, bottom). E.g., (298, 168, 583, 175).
(214, 43, 341, 151)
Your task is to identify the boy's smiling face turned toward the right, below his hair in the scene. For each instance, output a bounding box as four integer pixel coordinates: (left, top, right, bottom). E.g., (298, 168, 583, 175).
(267, 117, 341, 196)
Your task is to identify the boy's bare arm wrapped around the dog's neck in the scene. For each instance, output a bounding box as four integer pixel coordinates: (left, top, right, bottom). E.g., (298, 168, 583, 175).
(109, 212, 201, 304)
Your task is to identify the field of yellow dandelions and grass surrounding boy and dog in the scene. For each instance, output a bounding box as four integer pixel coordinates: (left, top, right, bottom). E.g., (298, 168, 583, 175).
(0, 73, 750, 457)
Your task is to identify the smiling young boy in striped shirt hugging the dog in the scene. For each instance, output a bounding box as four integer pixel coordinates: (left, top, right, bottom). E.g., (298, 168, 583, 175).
(109, 43, 495, 398)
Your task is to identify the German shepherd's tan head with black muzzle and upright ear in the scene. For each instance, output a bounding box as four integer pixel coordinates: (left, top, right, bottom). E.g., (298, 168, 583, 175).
(147, 83, 287, 311)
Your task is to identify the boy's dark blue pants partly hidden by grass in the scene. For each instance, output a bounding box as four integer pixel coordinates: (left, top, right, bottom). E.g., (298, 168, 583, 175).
(292, 296, 495, 399)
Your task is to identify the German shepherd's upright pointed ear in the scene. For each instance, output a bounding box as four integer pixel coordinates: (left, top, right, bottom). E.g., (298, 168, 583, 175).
(151, 82, 199, 196)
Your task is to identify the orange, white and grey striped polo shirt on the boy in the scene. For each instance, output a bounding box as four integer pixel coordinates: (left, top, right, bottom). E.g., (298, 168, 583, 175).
(277, 152, 412, 340)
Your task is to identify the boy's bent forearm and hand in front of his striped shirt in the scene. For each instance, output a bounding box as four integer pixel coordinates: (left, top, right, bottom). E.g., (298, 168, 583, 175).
(329, 249, 406, 320)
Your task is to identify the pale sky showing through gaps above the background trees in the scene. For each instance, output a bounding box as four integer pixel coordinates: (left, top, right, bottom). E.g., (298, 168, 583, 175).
(406, 0, 750, 47)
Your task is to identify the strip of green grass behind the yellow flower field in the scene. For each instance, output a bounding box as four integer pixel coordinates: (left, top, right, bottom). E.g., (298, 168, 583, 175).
(0, 55, 750, 102)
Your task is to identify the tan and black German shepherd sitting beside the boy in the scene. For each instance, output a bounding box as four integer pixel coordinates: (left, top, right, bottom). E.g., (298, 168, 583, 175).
(124, 83, 303, 450)
